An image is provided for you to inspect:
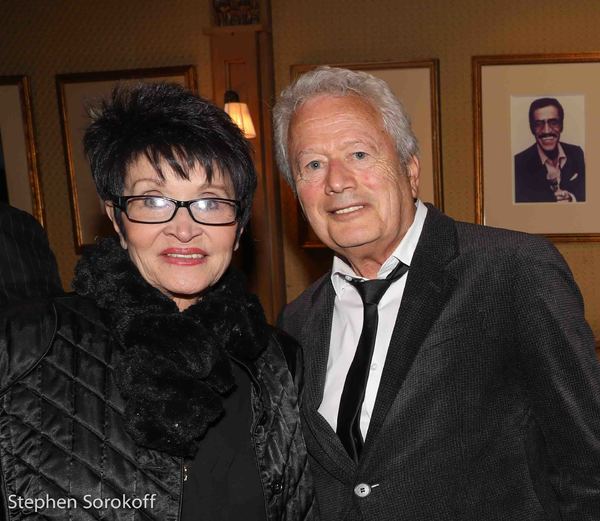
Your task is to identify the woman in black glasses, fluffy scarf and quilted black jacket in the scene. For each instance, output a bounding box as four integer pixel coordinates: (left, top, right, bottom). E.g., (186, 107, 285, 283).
(0, 84, 315, 521)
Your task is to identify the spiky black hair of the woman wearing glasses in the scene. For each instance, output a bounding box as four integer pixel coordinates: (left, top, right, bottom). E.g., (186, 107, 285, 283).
(83, 83, 257, 233)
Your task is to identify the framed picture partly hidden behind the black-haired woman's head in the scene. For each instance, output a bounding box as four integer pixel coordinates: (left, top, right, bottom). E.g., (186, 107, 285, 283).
(56, 65, 197, 252)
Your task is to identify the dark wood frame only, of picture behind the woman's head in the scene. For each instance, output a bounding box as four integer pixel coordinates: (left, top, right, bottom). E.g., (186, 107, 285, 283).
(56, 65, 197, 252)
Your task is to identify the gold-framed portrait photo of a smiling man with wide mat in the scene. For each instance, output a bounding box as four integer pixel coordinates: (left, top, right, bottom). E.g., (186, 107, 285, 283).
(472, 53, 600, 241)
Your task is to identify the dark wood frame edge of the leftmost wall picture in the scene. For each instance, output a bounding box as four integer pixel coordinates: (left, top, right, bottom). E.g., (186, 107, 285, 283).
(0, 75, 45, 226)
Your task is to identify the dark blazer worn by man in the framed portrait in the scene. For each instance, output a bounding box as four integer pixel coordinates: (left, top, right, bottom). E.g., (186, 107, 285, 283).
(515, 143, 585, 203)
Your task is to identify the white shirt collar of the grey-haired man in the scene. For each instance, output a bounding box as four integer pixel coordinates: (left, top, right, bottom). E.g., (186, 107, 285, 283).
(331, 199, 427, 295)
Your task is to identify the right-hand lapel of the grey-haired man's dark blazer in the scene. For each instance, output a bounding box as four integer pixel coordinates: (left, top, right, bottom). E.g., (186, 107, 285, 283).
(363, 205, 457, 455)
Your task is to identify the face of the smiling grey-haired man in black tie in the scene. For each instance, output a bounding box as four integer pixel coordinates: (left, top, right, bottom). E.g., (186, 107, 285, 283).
(289, 94, 419, 276)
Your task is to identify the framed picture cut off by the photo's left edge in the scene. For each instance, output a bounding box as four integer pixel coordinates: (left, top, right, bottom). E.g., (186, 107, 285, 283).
(0, 76, 44, 225)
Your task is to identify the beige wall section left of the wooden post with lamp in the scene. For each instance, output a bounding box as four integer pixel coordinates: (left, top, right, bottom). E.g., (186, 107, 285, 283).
(0, 0, 212, 287)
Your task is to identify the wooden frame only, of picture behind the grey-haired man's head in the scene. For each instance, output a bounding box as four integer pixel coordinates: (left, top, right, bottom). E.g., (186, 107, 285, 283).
(290, 59, 444, 248)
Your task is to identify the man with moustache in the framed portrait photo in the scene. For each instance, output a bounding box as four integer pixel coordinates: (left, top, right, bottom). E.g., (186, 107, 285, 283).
(515, 98, 585, 203)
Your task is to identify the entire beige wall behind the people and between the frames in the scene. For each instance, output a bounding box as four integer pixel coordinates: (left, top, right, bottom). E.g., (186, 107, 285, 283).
(0, 0, 600, 337)
